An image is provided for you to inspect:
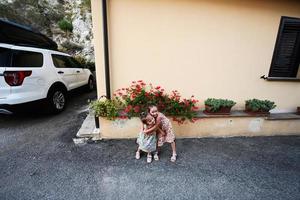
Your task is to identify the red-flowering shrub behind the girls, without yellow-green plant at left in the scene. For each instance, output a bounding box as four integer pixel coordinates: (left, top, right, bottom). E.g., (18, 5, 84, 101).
(114, 80, 198, 123)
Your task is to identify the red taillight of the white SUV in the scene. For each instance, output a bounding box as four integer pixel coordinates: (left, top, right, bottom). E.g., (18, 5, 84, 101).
(4, 71, 32, 86)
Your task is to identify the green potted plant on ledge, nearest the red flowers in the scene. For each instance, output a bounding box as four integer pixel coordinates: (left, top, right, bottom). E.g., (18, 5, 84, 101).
(204, 98, 236, 115)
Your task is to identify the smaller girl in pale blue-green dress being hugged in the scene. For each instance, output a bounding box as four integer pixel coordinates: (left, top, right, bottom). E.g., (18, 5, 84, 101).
(135, 112, 157, 163)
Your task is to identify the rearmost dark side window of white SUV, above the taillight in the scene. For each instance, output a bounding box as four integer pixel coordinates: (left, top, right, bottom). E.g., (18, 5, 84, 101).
(11, 50, 43, 67)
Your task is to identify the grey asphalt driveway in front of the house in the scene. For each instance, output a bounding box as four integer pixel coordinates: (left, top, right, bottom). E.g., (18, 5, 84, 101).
(0, 91, 300, 200)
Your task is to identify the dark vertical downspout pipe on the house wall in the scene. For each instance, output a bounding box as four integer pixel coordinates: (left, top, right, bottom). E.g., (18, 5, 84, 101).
(102, 0, 111, 99)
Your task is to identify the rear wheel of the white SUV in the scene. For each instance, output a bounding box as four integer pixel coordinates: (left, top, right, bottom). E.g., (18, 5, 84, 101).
(47, 88, 67, 113)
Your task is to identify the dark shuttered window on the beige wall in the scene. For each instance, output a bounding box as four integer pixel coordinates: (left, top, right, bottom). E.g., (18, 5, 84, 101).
(269, 17, 300, 79)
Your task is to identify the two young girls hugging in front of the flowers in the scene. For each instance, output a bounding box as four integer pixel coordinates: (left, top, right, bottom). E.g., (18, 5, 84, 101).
(135, 106, 177, 163)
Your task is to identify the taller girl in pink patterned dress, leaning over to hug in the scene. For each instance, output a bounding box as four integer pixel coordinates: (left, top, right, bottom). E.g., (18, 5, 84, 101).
(144, 105, 177, 162)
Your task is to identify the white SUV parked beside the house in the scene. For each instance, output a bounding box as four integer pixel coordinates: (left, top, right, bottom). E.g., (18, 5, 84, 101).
(0, 43, 94, 113)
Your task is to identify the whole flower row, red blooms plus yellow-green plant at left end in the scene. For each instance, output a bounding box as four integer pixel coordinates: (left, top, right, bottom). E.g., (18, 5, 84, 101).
(91, 80, 199, 123)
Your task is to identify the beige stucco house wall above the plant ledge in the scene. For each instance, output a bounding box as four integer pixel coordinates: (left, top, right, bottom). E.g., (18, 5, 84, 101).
(92, 0, 300, 111)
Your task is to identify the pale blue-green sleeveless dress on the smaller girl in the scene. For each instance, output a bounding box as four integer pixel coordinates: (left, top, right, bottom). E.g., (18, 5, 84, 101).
(136, 129, 157, 153)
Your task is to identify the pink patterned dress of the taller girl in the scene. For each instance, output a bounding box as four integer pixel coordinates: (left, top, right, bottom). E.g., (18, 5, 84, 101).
(157, 112, 175, 146)
